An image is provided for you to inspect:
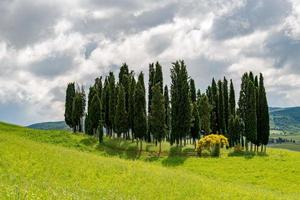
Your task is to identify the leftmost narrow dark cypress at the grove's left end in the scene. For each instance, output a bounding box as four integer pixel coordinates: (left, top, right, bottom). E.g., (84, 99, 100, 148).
(65, 83, 75, 128)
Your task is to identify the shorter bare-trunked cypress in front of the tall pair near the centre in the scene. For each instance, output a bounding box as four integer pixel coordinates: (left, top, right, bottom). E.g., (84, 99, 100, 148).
(149, 83, 166, 155)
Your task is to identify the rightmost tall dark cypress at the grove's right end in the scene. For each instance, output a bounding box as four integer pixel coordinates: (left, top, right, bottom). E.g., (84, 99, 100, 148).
(257, 74, 270, 152)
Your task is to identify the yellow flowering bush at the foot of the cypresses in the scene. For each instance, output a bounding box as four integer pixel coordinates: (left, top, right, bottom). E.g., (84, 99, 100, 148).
(196, 134, 228, 156)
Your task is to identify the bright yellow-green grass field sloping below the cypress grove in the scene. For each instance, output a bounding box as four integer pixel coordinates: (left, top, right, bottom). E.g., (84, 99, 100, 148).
(0, 123, 300, 199)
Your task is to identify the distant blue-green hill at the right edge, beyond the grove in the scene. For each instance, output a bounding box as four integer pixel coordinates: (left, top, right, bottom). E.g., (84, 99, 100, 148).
(269, 107, 300, 132)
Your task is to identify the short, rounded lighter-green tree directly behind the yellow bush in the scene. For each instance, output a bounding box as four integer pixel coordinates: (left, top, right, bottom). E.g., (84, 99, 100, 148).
(198, 94, 212, 134)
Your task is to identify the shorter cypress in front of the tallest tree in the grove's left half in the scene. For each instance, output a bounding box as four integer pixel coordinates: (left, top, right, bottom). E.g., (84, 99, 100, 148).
(114, 85, 128, 137)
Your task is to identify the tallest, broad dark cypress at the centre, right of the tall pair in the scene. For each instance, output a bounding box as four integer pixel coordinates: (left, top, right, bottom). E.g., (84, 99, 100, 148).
(171, 61, 191, 146)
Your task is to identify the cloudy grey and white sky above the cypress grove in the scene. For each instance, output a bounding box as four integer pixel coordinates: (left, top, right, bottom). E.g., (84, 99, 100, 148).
(0, 0, 300, 125)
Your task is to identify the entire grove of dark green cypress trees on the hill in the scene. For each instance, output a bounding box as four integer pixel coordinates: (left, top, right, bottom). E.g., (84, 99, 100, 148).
(65, 61, 270, 152)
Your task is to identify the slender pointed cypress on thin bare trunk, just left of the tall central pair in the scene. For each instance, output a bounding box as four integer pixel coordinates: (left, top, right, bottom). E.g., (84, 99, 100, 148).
(134, 72, 147, 151)
